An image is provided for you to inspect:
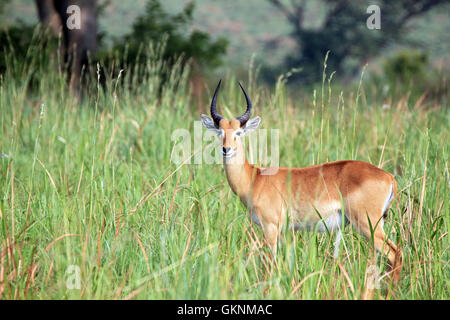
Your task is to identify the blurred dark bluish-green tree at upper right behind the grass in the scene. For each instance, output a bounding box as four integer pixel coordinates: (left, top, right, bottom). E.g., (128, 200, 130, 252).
(268, 0, 448, 82)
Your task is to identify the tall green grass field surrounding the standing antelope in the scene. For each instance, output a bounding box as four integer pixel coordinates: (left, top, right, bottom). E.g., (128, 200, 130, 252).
(0, 43, 450, 299)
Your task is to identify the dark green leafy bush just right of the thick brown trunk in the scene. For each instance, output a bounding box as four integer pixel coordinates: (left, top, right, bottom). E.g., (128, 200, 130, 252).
(99, 0, 228, 100)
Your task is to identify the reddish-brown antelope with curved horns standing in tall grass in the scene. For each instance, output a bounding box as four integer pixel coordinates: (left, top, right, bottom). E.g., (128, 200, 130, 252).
(201, 81, 402, 282)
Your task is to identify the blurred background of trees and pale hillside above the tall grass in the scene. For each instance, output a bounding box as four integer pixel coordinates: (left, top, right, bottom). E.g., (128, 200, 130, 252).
(0, 0, 450, 102)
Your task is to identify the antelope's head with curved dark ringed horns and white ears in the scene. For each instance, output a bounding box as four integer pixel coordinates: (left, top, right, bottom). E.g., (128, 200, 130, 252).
(201, 80, 261, 160)
